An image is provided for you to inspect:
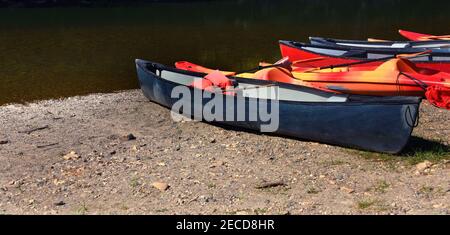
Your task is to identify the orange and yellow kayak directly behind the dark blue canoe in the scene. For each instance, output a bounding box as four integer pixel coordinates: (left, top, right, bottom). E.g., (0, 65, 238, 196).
(175, 58, 450, 108)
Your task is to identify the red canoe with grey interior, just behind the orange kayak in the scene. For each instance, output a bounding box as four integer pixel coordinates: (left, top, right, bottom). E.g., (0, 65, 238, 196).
(280, 40, 450, 73)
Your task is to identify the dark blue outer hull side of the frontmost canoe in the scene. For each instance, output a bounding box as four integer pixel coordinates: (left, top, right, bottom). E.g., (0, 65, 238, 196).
(136, 60, 420, 153)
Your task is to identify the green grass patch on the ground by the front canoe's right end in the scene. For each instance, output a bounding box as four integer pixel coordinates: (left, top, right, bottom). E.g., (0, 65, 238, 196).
(350, 137, 450, 165)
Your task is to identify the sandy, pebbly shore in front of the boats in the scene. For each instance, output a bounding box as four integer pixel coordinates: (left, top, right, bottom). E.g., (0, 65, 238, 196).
(0, 90, 450, 214)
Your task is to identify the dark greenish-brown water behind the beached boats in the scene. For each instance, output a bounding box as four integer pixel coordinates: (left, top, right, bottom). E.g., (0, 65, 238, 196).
(0, 0, 450, 104)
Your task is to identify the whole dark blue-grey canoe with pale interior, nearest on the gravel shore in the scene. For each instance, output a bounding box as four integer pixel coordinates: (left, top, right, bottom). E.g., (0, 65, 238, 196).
(136, 59, 421, 153)
